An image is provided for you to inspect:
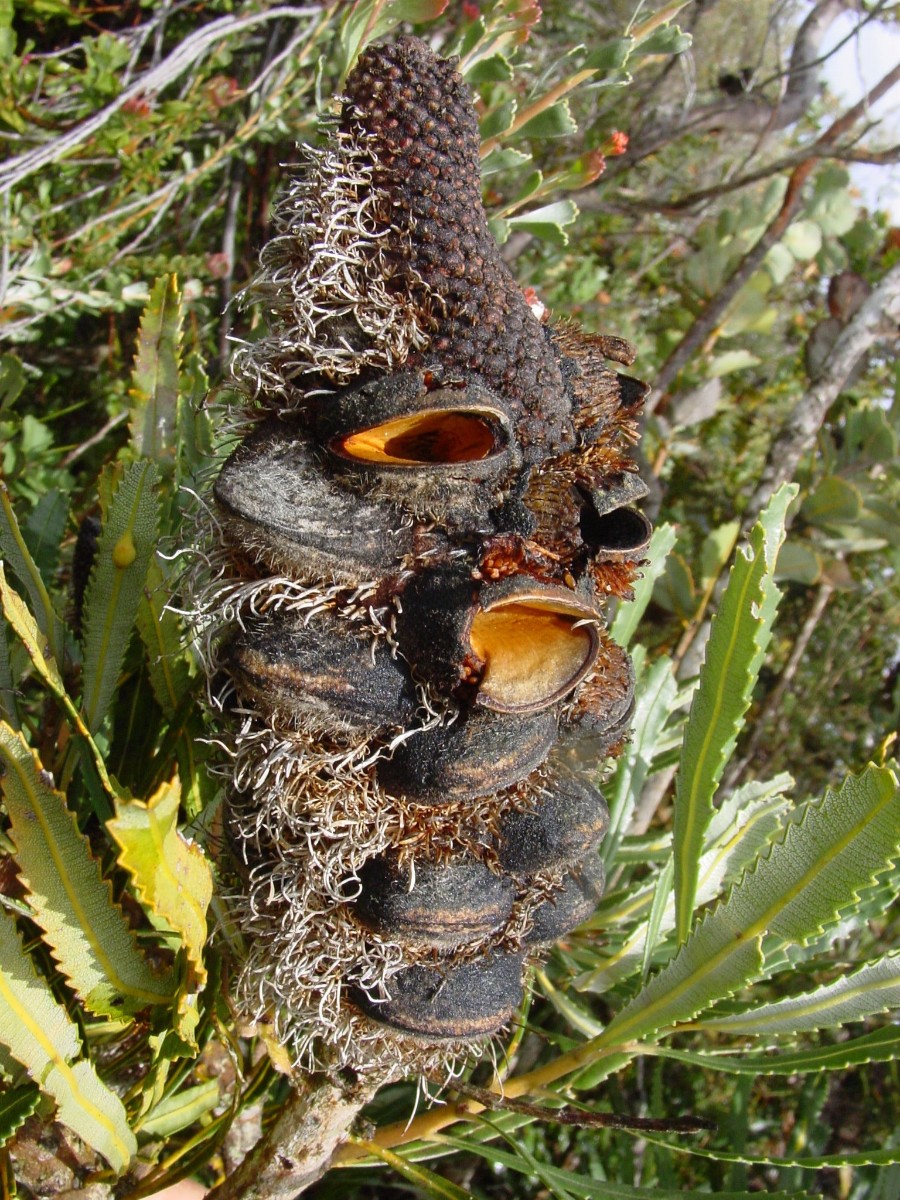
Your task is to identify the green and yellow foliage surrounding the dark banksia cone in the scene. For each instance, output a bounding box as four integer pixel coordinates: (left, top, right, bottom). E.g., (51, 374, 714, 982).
(0, 0, 900, 1200)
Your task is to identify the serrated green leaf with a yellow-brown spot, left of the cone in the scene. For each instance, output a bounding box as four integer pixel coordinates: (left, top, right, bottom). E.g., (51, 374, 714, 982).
(83, 461, 160, 733)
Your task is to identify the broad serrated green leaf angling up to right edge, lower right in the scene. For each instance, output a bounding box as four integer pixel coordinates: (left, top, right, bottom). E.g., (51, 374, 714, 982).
(594, 767, 900, 1049)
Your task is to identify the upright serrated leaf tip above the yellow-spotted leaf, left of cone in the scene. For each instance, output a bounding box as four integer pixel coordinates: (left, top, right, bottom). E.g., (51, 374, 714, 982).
(130, 275, 184, 472)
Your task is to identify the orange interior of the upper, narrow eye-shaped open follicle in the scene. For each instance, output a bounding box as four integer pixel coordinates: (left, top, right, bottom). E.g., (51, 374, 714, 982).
(338, 409, 498, 467)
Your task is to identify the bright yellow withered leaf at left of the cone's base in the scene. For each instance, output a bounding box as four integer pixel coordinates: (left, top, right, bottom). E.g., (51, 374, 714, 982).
(107, 779, 212, 990)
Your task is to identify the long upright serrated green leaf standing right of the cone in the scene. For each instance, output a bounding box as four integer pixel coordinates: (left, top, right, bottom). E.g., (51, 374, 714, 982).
(674, 485, 797, 942)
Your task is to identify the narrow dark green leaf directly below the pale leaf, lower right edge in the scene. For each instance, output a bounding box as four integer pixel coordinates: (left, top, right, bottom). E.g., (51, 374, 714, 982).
(656, 1022, 900, 1075)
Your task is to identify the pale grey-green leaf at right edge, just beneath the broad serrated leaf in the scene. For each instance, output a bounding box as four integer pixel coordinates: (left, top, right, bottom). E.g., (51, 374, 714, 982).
(701, 950, 900, 1037)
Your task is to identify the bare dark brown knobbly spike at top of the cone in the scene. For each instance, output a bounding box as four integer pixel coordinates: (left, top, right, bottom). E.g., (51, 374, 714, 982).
(342, 37, 575, 462)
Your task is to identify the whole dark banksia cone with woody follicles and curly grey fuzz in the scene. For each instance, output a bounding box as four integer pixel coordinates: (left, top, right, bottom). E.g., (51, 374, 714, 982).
(197, 38, 649, 1074)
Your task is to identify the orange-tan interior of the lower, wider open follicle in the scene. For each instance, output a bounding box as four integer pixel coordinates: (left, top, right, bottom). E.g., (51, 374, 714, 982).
(469, 599, 599, 712)
